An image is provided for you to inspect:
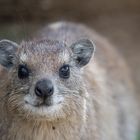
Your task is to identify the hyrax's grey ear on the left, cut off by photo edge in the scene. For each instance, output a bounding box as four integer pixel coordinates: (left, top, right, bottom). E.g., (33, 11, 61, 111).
(0, 39, 18, 68)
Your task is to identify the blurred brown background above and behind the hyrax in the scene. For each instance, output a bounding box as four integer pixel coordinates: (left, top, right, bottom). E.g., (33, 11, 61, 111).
(0, 0, 140, 111)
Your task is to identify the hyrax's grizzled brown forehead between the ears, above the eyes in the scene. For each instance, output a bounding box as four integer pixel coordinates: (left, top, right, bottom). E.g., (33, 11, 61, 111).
(18, 40, 72, 71)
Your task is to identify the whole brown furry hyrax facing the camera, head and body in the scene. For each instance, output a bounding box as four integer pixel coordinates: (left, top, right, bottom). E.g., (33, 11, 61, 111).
(0, 22, 137, 140)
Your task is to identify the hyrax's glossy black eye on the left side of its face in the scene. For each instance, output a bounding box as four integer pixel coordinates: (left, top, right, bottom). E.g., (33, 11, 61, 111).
(18, 65, 29, 79)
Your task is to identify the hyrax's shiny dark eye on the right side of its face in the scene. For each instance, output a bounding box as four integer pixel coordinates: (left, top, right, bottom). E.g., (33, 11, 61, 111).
(59, 65, 70, 79)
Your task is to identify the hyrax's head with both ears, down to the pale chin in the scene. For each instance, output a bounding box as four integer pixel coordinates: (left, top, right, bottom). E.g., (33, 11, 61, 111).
(0, 39, 94, 121)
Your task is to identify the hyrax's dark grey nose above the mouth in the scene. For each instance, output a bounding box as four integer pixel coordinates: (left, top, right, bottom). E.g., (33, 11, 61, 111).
(35, 79, 54, 99)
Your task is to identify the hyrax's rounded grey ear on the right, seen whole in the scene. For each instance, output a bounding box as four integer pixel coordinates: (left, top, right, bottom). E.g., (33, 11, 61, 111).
(71, 39, 95, 67)
